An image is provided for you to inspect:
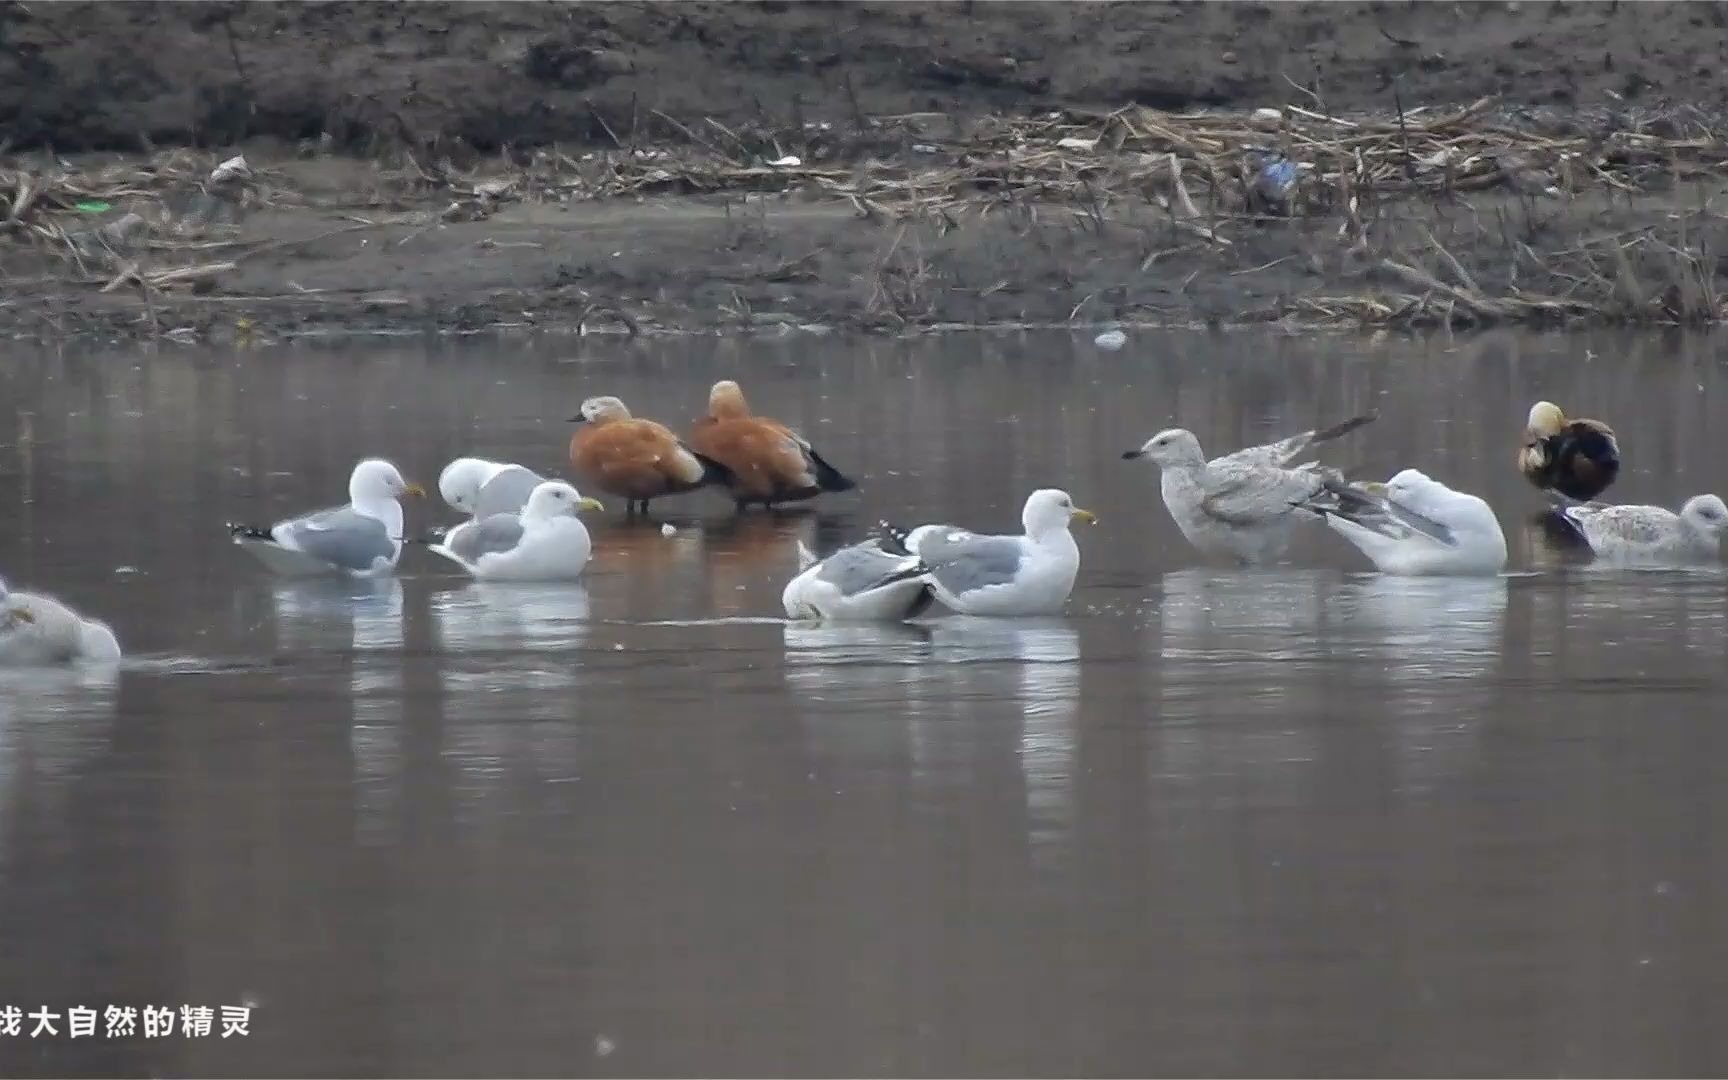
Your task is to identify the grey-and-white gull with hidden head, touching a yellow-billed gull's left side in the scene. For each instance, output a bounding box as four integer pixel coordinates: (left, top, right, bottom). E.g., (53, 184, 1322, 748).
(779, 539, 935, 622)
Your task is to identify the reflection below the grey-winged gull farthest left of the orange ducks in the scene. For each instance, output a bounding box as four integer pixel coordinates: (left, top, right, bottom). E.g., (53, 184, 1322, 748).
(271, 577, 403, 843)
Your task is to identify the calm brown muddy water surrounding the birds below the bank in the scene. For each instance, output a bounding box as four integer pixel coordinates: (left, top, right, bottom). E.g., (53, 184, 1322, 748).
(0, 335, 1728, 1077)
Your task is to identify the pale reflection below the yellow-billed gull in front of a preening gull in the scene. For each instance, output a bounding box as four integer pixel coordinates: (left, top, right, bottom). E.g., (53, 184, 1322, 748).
(432, 582, 589, 812)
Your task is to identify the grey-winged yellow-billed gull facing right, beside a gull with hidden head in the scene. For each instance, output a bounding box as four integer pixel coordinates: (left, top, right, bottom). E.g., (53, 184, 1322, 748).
(881, 487, 1097, 615)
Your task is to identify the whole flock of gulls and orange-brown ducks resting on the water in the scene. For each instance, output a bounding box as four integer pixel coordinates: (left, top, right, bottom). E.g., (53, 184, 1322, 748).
(0, 380, 1728, 665)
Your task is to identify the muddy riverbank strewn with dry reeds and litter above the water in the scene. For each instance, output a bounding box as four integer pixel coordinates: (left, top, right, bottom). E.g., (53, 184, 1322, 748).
(0, 3, 1728, 340)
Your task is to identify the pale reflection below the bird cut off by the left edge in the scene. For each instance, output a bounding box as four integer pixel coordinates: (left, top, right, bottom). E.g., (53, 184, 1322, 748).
(0, 667, 119, 864)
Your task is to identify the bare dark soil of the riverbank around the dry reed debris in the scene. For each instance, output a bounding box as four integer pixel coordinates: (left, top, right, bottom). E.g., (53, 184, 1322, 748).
(0, 2, 1728, 337)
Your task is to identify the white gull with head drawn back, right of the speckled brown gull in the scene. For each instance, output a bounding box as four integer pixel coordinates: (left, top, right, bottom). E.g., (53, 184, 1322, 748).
(1303, 468, 1507, 577)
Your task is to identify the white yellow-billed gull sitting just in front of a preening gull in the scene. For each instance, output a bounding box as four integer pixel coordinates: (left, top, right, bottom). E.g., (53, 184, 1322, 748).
(430, 480, 603, 581)
